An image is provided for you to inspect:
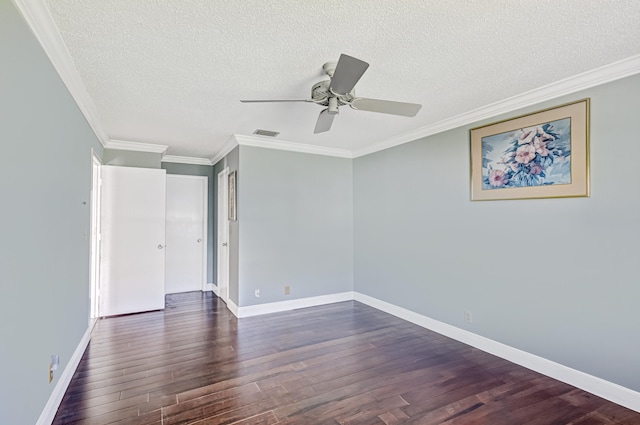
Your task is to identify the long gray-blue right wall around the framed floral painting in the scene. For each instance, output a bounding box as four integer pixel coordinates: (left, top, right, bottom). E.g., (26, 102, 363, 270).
(354, 75, 640, 391)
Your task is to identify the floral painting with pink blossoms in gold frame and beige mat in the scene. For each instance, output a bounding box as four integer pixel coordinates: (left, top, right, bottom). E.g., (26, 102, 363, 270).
(471, 99, 589, 201)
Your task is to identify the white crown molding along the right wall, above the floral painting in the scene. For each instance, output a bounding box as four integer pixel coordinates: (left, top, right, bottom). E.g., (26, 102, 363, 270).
(353, 55, 640, 158)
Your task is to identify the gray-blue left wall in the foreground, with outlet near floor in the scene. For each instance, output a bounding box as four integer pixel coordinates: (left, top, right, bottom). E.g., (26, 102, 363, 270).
(0, 0, 102, 424)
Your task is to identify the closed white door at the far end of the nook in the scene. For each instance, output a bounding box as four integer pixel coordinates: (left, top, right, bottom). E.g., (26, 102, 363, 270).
(165, 174, 207, 294)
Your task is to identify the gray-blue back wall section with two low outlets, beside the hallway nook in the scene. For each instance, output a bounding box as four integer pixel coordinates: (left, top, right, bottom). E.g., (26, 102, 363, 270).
(238, 146, 353, 307)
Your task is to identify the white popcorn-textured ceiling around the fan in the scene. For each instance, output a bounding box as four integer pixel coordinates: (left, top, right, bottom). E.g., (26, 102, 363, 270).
(45, 0, 640, 158)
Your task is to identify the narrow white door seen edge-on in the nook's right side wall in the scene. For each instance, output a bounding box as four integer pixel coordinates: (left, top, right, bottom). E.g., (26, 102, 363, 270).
(216, 168, 229, 303)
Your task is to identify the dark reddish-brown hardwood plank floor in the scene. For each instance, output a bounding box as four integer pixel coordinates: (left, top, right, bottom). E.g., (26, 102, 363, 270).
(54, 292, 640, 425)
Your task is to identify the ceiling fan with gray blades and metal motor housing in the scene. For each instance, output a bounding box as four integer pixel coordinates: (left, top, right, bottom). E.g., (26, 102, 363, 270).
(240, 54, 422, 134)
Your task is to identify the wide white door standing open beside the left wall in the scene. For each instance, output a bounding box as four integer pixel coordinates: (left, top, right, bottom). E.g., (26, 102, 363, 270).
(100, 166, 166, 316)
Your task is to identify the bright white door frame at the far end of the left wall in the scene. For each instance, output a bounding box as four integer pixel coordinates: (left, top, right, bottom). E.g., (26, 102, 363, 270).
(89, 148, 102, 326)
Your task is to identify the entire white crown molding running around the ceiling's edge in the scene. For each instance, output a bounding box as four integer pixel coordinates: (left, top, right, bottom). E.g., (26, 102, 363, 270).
(13, 0, 640, 165)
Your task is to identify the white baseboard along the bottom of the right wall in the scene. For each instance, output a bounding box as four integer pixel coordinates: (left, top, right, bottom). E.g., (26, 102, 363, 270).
(354, 292, 640, 412)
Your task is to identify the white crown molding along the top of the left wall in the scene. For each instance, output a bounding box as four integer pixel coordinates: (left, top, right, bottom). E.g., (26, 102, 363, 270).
(13, 0, 109, 147)
